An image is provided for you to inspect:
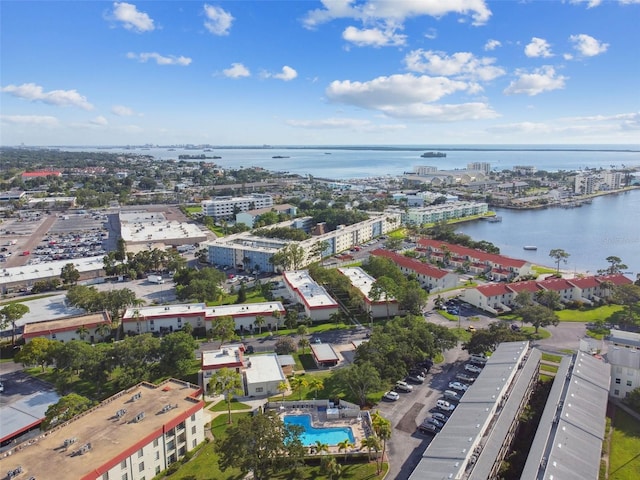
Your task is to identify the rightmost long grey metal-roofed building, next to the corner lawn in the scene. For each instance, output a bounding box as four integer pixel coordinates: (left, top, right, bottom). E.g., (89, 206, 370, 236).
(524, 352, 611, 480)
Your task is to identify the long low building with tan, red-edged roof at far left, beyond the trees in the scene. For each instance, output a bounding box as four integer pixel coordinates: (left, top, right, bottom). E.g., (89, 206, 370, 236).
(22, 312, 111, 343)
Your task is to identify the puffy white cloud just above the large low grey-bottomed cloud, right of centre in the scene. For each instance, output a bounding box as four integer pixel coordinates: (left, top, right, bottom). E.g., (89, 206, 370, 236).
(404, 50, 505, 82)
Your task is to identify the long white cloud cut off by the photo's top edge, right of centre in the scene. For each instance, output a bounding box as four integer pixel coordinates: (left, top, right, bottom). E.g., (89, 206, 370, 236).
(303, 0, 491, 28)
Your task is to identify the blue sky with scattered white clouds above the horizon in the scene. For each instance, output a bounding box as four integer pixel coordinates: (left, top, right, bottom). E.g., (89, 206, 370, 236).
(0, 0, 640, 145)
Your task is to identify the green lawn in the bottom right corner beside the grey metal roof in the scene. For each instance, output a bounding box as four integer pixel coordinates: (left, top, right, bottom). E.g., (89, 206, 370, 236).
(609, 408, 640, 480)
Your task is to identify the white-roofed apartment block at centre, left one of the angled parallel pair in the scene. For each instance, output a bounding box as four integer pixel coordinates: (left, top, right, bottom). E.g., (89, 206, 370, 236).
(282, 270, 340, 321)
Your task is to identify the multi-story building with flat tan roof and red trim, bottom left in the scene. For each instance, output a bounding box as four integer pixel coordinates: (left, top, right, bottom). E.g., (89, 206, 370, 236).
(2, 380, 205, 480)
